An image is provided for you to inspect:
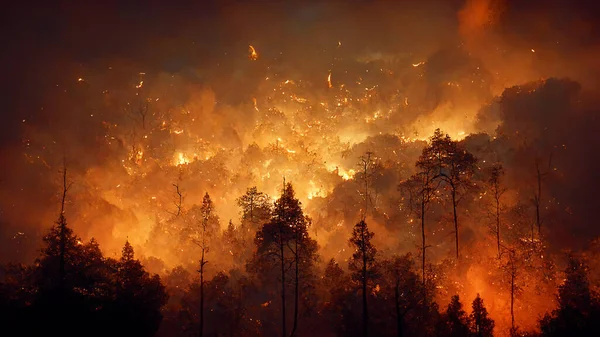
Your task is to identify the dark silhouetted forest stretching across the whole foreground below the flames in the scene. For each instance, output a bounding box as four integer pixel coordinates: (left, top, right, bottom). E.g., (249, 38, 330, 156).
(0, 124, 600, 336)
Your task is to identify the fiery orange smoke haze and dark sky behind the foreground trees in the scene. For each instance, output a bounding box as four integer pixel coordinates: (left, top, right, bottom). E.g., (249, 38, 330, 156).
(0, 1, 598, 328)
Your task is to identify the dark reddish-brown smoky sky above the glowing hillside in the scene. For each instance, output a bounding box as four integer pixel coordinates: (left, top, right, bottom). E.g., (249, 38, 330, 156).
(0, 0, 600, 260)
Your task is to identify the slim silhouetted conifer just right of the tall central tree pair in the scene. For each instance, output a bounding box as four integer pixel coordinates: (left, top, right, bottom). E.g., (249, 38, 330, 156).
(349, 220, 378, 337)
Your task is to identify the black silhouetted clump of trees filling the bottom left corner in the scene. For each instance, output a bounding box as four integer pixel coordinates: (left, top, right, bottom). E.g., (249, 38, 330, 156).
(0, 216, 168, 336)
